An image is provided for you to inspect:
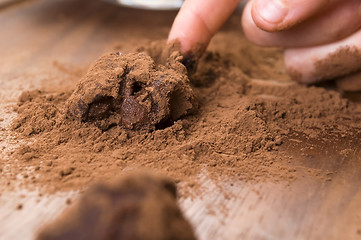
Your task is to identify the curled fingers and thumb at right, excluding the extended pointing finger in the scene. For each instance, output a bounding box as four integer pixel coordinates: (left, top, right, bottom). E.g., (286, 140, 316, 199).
(242, 0, 361, 90)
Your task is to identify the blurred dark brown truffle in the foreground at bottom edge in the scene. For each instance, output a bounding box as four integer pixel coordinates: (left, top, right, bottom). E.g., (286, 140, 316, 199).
(37, 173, 195, 240)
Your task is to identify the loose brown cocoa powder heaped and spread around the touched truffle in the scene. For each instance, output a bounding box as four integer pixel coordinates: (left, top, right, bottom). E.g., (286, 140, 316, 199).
(4, 41, 361, 192)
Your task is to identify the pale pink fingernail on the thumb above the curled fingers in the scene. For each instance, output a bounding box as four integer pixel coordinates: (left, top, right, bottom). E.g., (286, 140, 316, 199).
(255, 0, 288, 24)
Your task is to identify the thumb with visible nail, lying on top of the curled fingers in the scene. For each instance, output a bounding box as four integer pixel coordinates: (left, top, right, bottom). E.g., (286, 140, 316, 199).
(251, 0, 336, 32)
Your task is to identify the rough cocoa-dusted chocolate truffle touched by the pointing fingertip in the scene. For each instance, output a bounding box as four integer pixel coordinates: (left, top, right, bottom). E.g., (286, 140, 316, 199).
(67, 52, 196, 130)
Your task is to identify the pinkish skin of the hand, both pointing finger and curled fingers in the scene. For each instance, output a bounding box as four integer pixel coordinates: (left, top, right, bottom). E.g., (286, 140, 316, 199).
(168, 0, 361, 90)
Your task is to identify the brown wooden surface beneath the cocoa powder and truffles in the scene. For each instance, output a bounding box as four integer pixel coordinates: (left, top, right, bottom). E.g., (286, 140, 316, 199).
(0, 0, 361, 240)
